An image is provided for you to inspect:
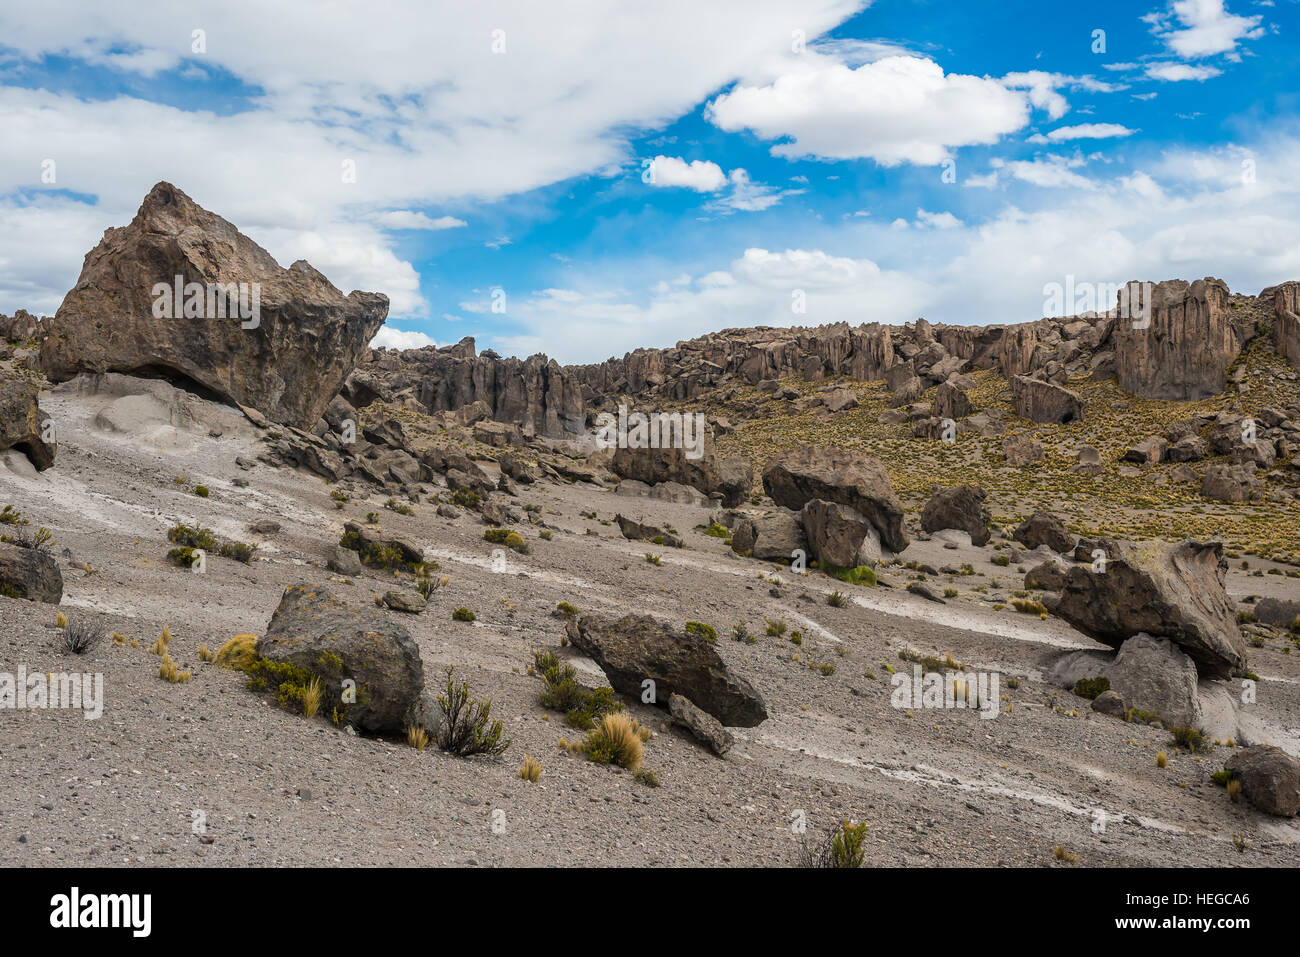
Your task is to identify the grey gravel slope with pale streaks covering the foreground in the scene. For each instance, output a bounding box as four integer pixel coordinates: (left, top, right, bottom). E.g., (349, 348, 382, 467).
(0, 387, 1300, 867)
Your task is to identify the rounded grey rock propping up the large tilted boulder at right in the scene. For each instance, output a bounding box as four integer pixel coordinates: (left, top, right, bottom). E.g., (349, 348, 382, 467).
(1106, 635, 1201, 728)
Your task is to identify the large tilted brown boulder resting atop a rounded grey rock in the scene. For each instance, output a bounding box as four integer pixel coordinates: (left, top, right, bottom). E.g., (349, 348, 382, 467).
(1053, 540, 1245, 677)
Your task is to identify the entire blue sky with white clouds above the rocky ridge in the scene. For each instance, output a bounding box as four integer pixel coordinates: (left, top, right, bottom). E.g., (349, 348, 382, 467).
(0, 0, 1300, 361)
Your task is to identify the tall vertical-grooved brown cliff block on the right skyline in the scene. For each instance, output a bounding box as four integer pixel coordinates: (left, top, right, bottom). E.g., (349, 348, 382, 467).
(1113, 278, 1244, 402)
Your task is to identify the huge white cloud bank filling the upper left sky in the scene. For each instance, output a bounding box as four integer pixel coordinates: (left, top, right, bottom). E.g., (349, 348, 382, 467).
(0, 0, 861, 316)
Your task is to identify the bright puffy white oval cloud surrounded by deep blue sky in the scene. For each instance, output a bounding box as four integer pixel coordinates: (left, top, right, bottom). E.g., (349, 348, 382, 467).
(706, 56, 1030, 166)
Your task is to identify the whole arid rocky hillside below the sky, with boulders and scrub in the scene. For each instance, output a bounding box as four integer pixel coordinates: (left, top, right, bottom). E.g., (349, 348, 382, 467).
(0, 185, 1300, 867)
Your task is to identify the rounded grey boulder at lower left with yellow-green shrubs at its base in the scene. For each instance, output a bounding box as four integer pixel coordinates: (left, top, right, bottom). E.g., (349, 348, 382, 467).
(257, 585, 424, 733)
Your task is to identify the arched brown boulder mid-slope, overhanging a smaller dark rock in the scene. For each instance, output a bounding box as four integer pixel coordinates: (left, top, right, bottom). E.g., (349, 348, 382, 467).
(763, 445, 907, 551)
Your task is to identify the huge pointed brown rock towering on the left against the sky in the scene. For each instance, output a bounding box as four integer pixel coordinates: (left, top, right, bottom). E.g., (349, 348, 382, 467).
(40, 183, 389, 429)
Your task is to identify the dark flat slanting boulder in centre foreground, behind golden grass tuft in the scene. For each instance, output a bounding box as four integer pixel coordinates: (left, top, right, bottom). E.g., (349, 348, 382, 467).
(567, 615, 767, 728)
